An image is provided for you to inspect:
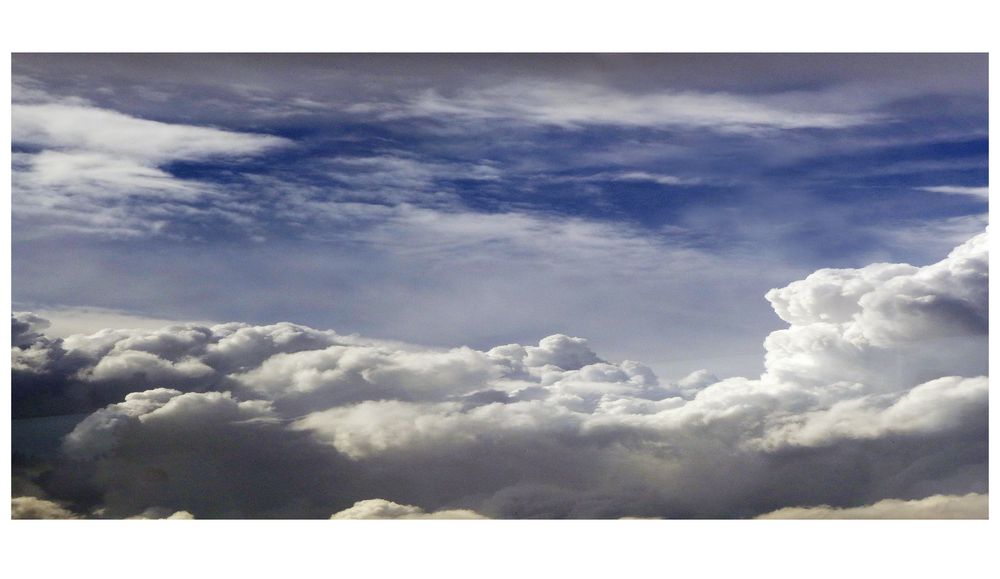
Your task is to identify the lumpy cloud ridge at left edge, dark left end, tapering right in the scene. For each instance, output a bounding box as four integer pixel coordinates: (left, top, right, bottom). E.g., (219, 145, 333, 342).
(11, 312, 352, 417)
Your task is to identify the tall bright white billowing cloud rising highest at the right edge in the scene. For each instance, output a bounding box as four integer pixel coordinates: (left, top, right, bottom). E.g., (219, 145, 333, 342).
(764, 233, 989, 392)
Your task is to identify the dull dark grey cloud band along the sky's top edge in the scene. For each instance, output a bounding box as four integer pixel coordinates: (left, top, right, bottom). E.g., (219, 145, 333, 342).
(13, 53, 987, 105)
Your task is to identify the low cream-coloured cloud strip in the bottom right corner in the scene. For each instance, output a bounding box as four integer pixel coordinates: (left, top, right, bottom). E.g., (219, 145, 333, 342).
(757, 493, 989, 519)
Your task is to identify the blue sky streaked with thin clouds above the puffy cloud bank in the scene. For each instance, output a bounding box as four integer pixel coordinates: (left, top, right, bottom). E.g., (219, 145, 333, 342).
(12, 54, 988, 377)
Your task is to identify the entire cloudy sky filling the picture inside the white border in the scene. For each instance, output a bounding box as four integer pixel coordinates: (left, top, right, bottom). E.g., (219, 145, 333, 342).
(11, 54, 988, 518)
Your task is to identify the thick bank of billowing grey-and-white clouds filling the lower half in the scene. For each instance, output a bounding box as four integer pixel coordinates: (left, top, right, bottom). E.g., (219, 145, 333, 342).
(12, 233, 988, 518)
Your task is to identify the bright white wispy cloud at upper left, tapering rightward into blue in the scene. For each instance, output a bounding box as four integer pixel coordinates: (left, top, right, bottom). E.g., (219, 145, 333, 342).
(11, 89, 291, 236)
